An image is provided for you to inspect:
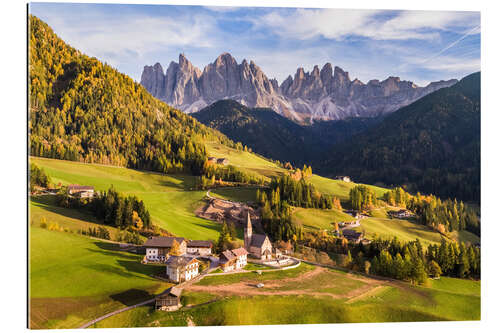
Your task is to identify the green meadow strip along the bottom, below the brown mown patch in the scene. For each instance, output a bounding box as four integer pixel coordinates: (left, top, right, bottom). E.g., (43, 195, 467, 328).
(95, 276, 481, 328)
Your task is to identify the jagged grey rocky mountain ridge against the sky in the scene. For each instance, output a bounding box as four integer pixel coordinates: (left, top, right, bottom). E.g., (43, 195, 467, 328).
(141, 53, 458, 122)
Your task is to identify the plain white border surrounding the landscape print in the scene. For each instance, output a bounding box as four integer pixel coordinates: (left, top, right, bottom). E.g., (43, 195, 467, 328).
(0, 0, 500, 333)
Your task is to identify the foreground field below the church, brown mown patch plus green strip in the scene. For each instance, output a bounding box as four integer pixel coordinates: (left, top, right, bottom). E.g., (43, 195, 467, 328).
(95, 260, 480, 327)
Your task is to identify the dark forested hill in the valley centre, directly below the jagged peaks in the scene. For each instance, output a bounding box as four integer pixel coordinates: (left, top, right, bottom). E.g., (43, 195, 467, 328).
(191, 99, 380, 167)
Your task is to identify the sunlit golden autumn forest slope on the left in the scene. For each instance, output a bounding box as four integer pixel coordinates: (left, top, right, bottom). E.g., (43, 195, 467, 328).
(28, 16, 232, 174)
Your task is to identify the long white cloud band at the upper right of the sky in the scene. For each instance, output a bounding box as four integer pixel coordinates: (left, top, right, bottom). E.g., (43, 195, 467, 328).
(252, 9, 479, 40)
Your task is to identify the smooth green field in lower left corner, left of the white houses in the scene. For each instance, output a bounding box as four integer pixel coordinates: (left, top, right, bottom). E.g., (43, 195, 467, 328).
(29, 227, 170, 328)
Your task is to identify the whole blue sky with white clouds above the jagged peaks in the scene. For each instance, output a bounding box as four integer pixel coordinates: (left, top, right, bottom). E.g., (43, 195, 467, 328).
(30, 3, 481, 86)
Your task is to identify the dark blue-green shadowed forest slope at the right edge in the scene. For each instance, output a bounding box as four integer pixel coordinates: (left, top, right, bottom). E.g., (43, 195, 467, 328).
(319, 72, 481, 202)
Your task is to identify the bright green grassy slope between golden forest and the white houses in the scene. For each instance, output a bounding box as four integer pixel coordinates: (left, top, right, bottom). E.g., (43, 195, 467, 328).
(31, 157, 220, 240)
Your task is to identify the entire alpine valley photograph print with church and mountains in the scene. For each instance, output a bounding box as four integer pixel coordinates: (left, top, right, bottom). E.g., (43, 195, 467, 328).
(26, 2, 481, 329)
